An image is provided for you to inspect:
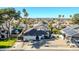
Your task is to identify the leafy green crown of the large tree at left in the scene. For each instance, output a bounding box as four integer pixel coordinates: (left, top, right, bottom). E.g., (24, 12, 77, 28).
(0, 8, 20, 23)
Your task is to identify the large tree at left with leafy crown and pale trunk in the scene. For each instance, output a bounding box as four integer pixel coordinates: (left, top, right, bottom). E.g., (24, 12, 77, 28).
(0, 8, 20, 37)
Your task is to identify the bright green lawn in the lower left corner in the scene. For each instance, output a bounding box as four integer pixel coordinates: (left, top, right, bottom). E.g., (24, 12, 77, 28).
(0, 38, 16, 48)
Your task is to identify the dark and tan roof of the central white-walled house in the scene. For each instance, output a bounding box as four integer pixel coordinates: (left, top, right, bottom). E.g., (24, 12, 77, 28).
(24, 22, 49, 36)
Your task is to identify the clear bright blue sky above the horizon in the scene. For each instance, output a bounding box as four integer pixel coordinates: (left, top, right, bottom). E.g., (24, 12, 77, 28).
(0, 7, 79, 18)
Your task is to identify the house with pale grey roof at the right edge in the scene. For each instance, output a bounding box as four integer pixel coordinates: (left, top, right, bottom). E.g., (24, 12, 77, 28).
(61, 25, 79, 47)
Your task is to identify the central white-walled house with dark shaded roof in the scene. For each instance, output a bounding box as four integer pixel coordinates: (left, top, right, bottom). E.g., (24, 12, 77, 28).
(23, 23, 50, 41)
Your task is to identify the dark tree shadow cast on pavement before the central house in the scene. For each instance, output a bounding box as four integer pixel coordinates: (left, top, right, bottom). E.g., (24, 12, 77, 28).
(32, 37, 55, 49)
